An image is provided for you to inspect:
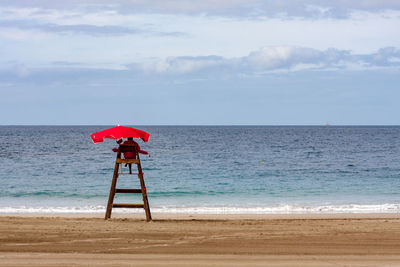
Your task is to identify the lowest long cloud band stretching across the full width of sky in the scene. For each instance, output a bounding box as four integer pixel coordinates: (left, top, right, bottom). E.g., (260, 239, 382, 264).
(0, 46, 400, 82)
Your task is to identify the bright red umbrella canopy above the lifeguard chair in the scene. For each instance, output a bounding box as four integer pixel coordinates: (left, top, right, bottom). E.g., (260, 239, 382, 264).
(90, 125, 150, 143)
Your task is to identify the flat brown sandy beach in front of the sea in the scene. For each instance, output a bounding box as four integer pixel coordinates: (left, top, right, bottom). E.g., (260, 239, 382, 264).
(0, 214, 400, 266)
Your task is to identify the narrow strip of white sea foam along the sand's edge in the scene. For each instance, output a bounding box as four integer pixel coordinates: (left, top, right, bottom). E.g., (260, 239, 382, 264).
(0, 204, 400, 214)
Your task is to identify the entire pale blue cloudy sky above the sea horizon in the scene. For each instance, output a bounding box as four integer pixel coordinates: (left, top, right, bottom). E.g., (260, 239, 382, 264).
(0, 0, 400, 125)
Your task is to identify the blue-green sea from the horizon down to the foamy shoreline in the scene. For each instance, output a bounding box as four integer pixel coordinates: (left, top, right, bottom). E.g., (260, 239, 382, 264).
(0, 126, 400, 214)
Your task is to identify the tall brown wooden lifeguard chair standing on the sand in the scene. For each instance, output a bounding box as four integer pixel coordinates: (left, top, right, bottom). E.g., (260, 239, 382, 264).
(105, 144, 151, 222)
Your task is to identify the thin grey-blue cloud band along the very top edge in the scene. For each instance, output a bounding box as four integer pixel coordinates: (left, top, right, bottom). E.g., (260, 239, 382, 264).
(2, 0, 400, 19)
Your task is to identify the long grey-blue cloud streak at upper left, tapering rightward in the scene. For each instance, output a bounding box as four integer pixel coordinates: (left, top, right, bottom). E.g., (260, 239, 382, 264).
(0, 5, 185, 39)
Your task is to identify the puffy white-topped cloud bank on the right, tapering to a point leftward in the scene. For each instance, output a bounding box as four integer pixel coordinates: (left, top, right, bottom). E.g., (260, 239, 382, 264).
(134, 46, 400, 74)
